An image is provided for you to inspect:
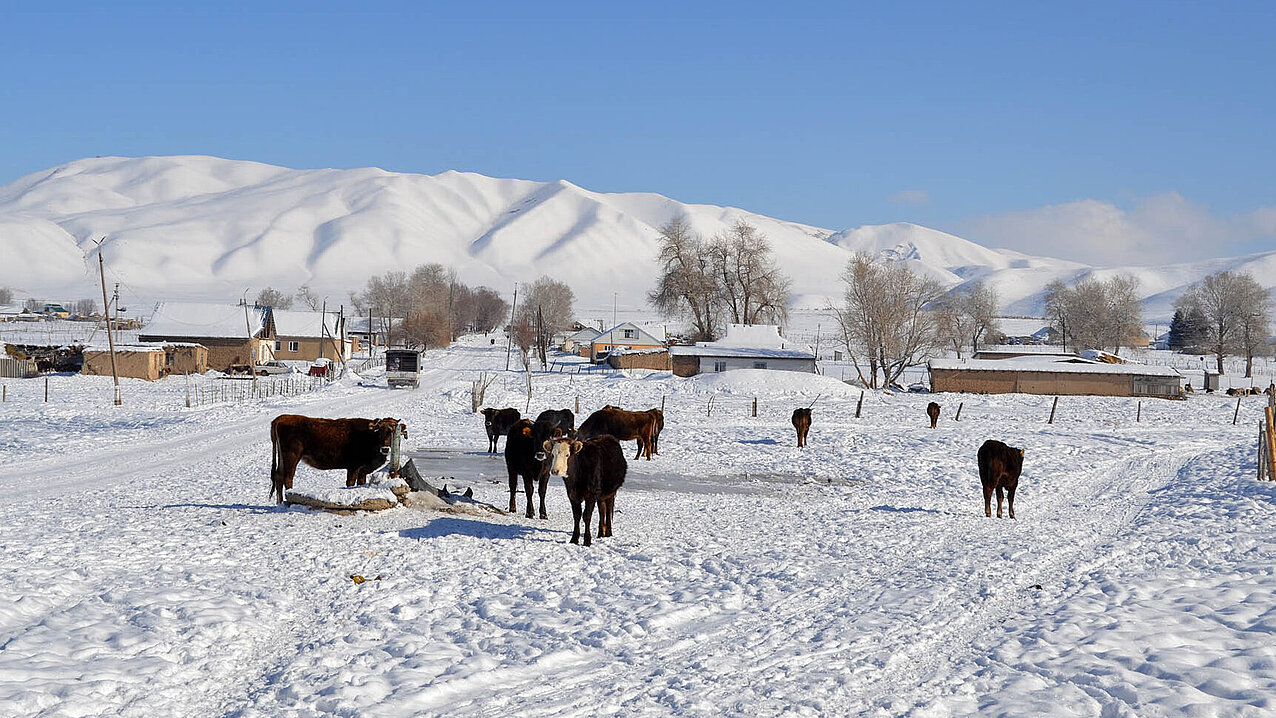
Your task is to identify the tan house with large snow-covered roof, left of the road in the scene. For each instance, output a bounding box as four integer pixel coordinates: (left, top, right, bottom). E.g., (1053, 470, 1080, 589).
(138, 302, 274, 371)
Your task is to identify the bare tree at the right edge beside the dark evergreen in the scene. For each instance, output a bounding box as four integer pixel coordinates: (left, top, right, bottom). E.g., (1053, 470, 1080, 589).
(1175, 272, 1271, 376)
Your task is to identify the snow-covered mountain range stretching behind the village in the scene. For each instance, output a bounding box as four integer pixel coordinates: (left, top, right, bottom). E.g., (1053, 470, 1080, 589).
(0, 157, 1276, 319)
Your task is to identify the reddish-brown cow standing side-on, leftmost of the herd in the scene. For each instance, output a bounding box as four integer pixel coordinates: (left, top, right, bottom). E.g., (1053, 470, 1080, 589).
(271, 414, 407, 502)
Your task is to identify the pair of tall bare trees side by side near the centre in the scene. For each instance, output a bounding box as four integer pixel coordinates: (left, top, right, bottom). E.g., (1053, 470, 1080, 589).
(647, 216, 792, 342)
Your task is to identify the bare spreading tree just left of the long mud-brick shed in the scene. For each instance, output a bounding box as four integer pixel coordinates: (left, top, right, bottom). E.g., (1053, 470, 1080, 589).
(838, 253, 943, 388)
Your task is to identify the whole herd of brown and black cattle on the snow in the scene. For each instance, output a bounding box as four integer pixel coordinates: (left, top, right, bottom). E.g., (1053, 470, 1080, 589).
(271, 402, 1023, 546)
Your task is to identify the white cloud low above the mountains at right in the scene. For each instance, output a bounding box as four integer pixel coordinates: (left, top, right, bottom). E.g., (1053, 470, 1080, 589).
(958, 193, 1276, 265)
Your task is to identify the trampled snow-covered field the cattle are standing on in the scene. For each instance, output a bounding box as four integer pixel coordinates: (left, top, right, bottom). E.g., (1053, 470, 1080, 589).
(0, 338, 1276, 717)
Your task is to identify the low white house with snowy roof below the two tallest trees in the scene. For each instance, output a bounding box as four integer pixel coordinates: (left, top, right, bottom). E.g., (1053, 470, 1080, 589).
(669, 324, 815, 376)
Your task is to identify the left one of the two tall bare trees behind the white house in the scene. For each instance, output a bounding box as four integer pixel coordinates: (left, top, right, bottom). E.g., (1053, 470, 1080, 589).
(647, 214, 722, 342)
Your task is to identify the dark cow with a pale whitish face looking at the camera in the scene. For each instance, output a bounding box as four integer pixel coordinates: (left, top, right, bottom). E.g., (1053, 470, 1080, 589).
(541, 436, 629, 546)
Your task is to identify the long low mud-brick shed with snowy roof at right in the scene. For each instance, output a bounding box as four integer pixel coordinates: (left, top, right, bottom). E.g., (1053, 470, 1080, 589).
(928, 357, 1183, 399)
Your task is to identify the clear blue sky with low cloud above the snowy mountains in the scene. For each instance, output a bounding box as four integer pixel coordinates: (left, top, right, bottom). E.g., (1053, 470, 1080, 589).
(0, 1, 1276, 263)
